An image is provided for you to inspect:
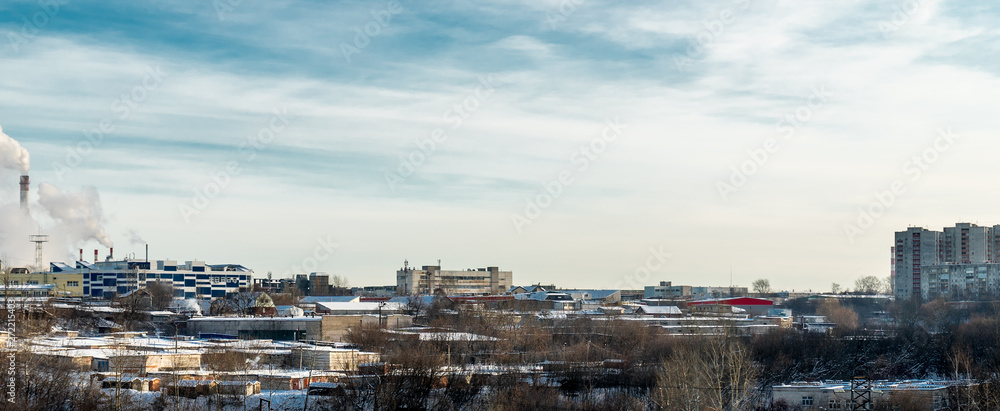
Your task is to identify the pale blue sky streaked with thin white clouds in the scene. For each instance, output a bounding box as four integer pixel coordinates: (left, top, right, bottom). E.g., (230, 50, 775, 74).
(0, 0, 1000, 291)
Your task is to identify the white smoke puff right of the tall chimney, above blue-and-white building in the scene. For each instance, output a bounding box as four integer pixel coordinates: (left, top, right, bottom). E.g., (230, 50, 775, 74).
(38, 183, 114, 247)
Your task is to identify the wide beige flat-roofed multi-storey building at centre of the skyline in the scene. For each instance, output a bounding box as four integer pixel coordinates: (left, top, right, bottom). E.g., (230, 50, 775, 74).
(396, 261, 514, 296)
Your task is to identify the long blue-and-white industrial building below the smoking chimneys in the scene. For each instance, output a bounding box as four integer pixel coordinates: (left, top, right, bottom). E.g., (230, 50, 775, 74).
(46, 256, 253, 300)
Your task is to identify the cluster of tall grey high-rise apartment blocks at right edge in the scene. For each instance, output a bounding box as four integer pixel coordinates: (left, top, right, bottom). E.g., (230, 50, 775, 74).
(892, 223, 1000, 299)
